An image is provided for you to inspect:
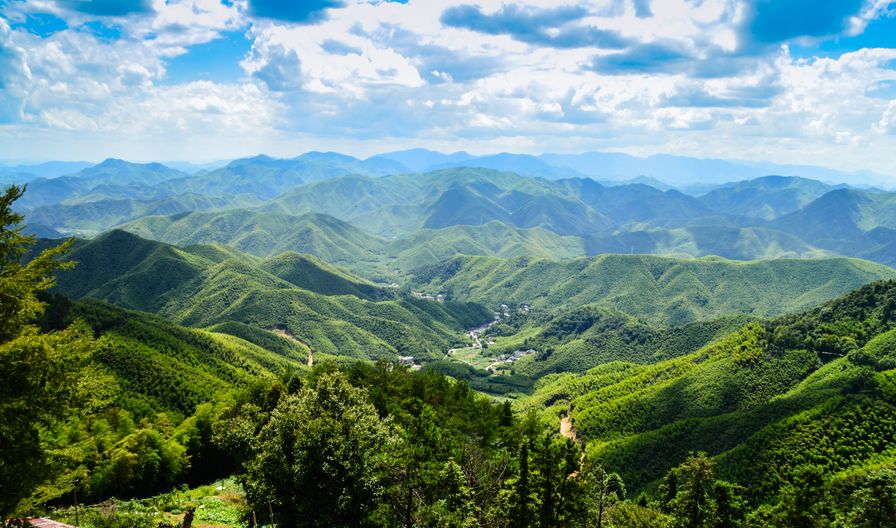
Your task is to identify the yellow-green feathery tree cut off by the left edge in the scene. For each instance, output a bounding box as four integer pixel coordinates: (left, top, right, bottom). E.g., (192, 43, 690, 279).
(0, 186, 96, 517)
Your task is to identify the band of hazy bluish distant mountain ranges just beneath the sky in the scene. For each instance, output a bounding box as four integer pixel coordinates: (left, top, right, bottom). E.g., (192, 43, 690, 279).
(12, 149, 896, 274)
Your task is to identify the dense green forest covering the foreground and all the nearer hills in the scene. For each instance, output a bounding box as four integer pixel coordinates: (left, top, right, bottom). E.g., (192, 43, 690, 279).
(0, 178, 896, 528)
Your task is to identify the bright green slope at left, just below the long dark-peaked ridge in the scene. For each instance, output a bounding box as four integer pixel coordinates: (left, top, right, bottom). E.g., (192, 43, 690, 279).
(63, 299, 308, 413)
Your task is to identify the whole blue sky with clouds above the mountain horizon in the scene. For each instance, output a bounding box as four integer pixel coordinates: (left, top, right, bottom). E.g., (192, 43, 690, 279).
(0, 0, 896, 175)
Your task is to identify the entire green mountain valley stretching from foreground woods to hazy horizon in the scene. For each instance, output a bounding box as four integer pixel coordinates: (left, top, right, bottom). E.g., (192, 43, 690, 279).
(0, 153, 896, 526)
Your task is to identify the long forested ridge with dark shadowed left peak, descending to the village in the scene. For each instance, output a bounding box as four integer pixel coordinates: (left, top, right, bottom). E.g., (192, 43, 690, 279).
(56, 231, 491, 359)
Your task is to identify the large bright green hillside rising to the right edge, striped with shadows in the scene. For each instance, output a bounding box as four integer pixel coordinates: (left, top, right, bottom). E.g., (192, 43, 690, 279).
(520, 281, 896, 499)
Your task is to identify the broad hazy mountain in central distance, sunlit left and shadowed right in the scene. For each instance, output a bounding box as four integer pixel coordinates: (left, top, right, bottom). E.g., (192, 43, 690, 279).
(266, 168, 610, 237)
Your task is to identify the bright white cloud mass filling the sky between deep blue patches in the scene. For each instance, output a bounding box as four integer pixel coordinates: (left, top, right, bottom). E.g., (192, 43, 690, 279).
(0, 0, 896, 172)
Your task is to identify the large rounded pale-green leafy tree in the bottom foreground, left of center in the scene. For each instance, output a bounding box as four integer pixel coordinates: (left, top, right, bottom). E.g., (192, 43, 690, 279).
(242, 373, 399, 527)
